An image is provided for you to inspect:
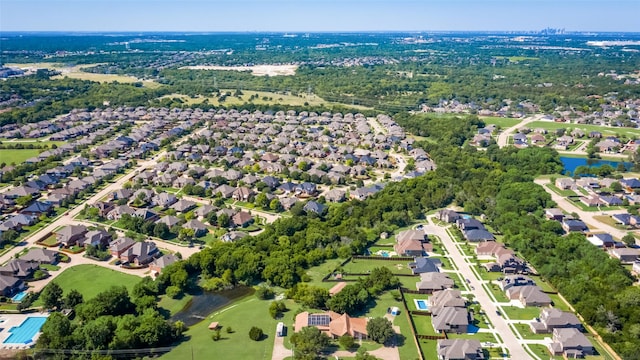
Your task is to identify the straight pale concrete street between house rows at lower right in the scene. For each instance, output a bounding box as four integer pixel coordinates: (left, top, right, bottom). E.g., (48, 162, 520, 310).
(424, 215, 531, 360)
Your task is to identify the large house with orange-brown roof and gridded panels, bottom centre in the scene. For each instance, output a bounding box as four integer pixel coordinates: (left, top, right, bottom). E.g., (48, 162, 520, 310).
(294, 311, 369, 339)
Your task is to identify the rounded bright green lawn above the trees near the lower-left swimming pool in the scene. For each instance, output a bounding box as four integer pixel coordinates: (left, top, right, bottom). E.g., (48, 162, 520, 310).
(34, 265, 140, 306)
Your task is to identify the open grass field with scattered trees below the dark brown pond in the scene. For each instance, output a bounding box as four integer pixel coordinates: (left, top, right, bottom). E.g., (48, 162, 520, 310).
(162, 296, 276, 360)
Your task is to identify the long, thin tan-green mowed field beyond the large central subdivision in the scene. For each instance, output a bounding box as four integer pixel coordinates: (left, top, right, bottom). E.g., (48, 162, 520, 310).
(162, 89, 367, 109)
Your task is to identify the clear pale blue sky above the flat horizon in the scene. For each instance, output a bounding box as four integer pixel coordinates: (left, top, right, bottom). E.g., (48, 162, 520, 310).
(0, 0, 640, 32)
